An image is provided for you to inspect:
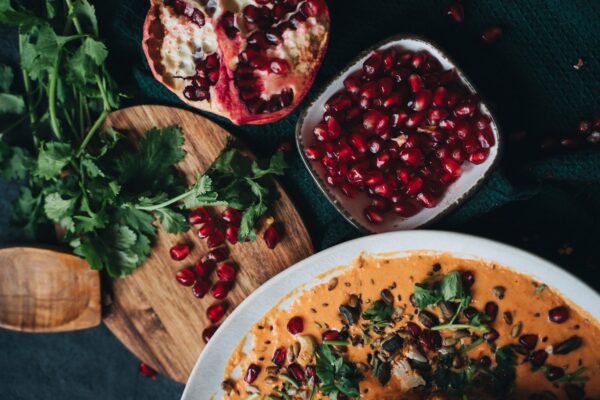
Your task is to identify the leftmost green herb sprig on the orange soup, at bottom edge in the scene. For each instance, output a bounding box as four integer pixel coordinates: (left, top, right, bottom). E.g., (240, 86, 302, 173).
(316, 345, 363, 400)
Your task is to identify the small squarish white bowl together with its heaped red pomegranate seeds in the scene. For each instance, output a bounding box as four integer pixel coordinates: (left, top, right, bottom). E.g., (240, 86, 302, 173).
(296, 36, 500, 232)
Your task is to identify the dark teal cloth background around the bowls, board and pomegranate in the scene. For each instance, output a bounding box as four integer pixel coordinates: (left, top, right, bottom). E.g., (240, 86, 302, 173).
(0, 0, 600, 399)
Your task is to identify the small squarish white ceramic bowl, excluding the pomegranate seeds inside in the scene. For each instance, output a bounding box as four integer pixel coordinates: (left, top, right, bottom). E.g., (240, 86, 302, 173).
(296, 35, 502, 233)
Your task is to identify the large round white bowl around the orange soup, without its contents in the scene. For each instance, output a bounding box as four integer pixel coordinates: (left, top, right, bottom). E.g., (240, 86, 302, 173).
(182, 230, 600, 400)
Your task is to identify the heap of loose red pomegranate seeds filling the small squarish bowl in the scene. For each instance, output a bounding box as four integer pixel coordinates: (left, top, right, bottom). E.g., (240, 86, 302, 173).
(305, 48, 495, 224)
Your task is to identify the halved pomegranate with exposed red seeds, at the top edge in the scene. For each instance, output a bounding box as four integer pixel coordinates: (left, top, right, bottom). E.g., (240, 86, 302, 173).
(142, 0, 329, 124)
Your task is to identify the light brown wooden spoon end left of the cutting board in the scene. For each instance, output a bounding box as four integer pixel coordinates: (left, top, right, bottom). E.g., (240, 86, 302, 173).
(0, 247, 101, 332)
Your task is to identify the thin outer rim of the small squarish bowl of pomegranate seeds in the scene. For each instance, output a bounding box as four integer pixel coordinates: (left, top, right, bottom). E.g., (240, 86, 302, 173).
(295, 33, 504, 233)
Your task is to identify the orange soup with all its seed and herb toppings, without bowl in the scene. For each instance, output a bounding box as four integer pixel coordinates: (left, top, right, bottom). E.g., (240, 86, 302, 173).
(222, 253, 600, 399)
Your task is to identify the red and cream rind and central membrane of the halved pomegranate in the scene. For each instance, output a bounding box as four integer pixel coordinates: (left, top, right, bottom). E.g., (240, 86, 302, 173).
(142, 0, 330, 125)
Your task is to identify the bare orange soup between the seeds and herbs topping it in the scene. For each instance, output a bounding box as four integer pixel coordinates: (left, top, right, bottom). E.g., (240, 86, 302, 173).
(224, 254, 600, 400)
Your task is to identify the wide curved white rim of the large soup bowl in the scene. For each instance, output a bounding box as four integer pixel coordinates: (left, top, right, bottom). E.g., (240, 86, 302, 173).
(181, 230, 600, 400)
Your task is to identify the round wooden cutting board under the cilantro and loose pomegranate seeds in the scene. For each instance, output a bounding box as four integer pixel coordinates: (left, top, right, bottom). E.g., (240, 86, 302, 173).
(104, 106, 313, 383)
